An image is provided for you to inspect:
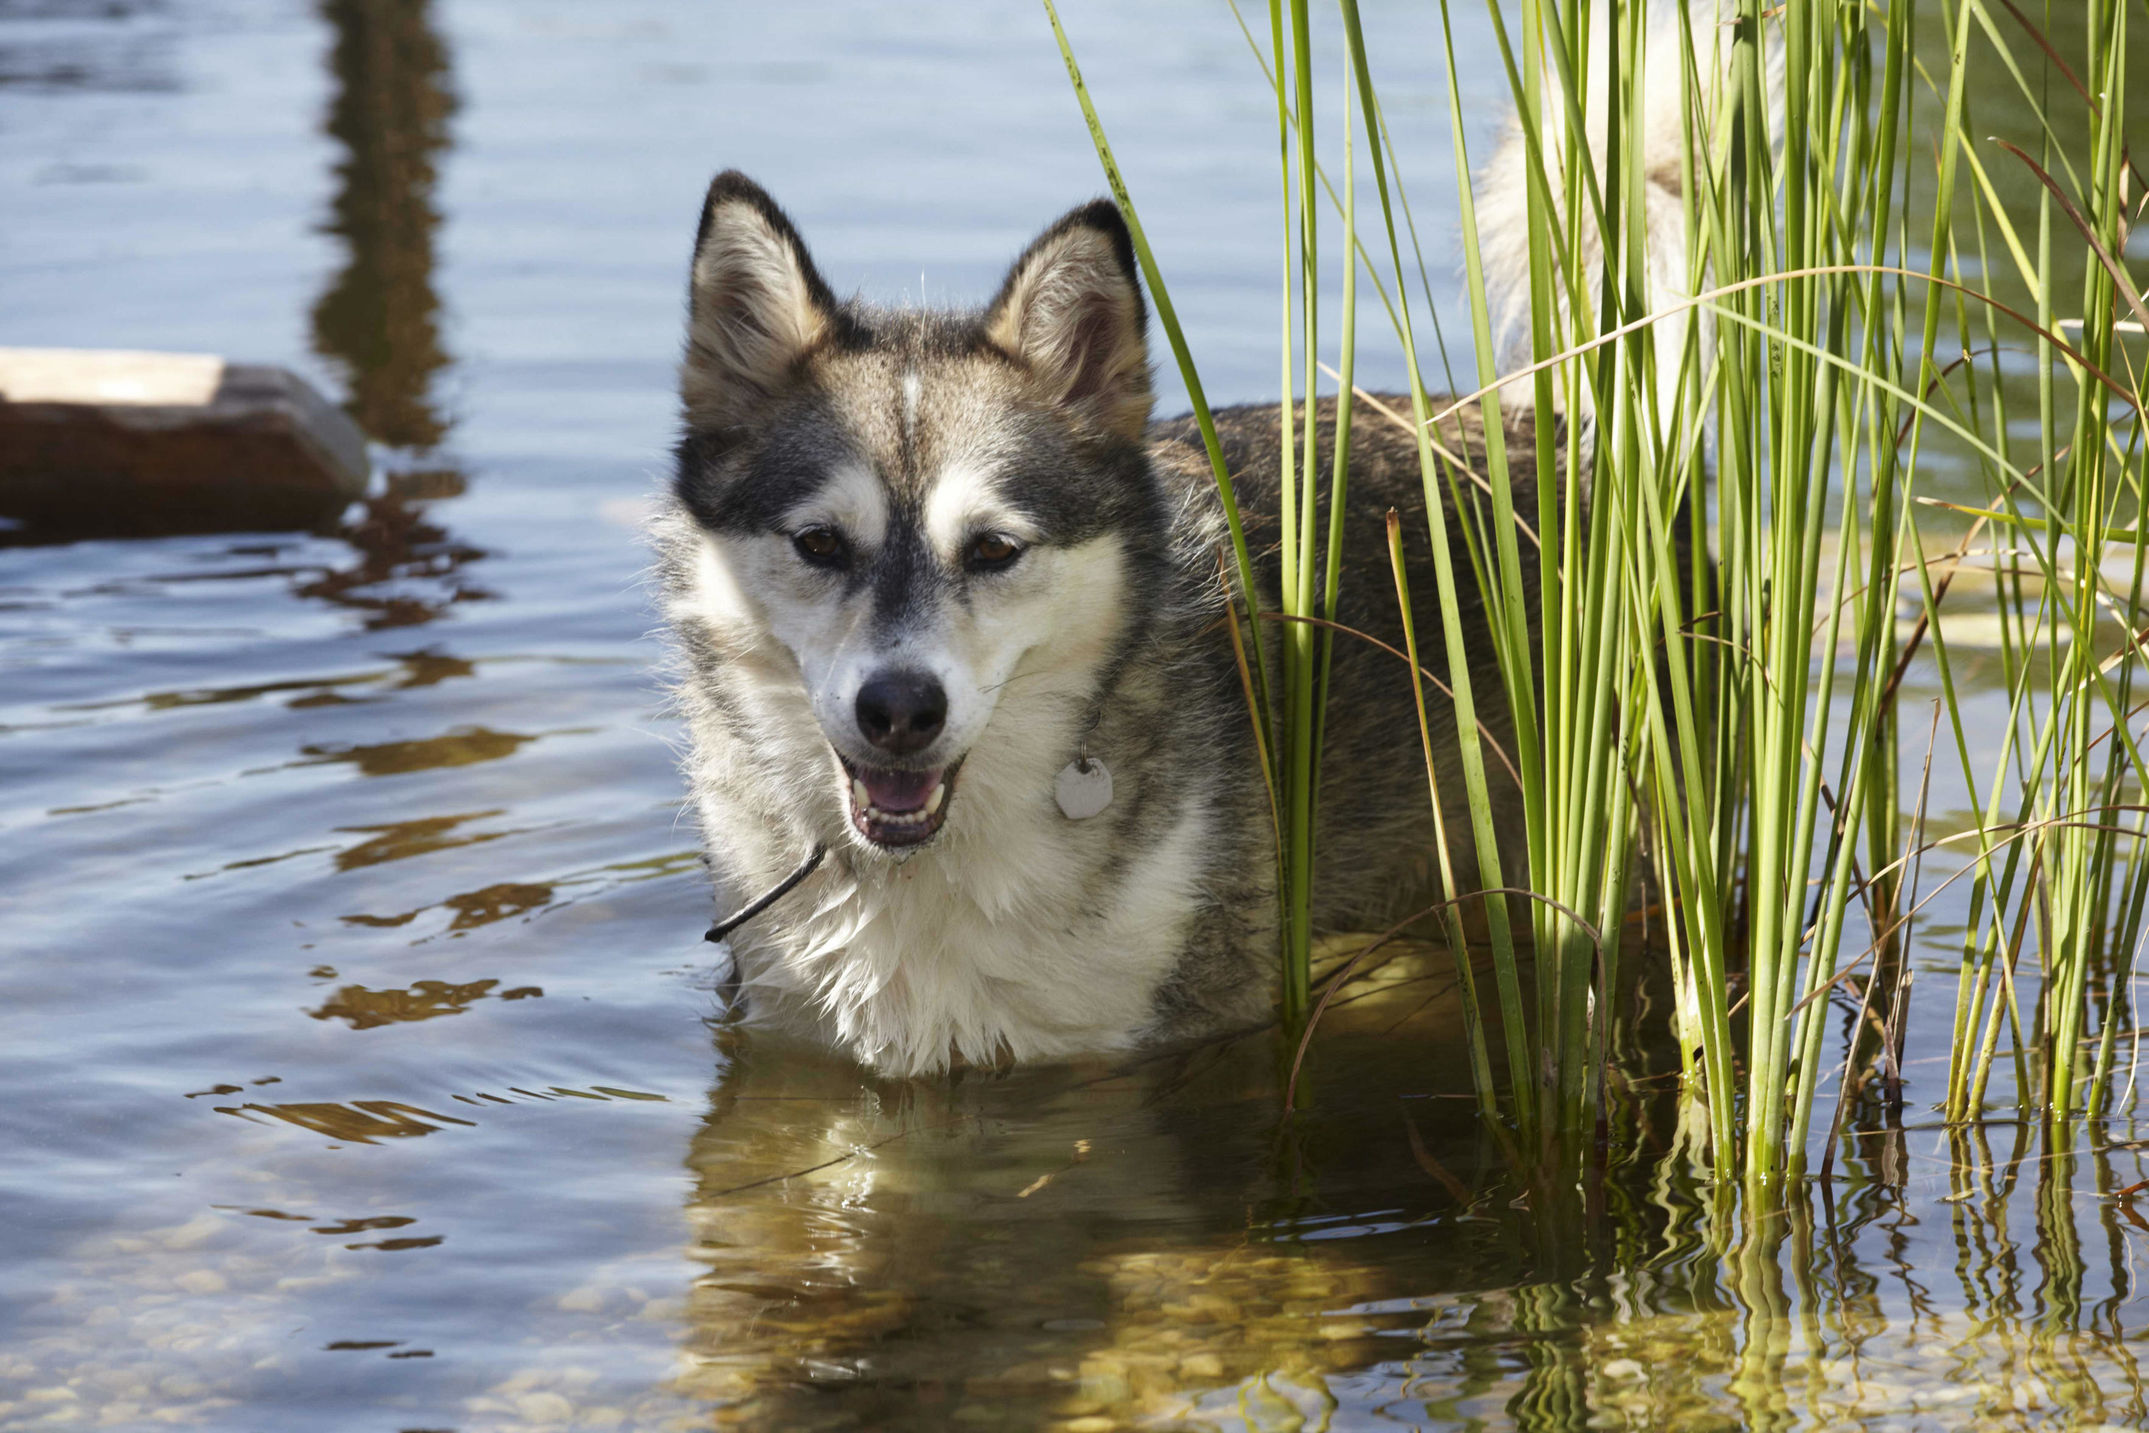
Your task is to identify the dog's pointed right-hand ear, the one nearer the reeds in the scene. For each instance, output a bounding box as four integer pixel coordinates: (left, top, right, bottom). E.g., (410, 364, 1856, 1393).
(984, 200, 1156, 438)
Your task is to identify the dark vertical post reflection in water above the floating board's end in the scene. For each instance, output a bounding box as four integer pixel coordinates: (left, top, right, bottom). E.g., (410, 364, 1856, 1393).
(314, 0, 456, 449)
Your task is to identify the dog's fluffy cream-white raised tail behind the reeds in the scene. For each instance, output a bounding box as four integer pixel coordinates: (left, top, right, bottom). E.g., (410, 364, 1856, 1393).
(1476, 0, 1777, 421)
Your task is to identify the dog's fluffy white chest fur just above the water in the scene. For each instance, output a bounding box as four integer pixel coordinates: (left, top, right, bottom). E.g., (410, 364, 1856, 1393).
(733, 793, 1206, 1074)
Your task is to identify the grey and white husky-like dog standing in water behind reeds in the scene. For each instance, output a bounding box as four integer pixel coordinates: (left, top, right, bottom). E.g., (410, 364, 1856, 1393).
(653, 19, 1719, 1076)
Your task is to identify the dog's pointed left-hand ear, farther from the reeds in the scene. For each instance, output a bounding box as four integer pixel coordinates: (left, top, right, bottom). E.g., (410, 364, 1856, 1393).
(679, 170, 838, 428)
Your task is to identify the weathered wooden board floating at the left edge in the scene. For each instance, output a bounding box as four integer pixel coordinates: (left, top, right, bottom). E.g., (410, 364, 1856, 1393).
(0, 348, 370, 533)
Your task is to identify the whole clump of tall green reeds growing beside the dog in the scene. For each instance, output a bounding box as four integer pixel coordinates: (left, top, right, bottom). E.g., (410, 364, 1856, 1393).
(1047, 0, 2149, 1190)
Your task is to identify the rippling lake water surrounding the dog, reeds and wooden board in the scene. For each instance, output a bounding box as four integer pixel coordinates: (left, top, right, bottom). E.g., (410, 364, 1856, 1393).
(0, 0, 2149, 1433)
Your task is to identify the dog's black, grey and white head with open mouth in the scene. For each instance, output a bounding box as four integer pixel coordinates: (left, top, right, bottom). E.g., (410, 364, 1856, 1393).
(677, 172, 1158, 853)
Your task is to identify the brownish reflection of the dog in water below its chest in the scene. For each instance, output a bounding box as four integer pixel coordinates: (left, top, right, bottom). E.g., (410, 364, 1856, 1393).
(677, 956, 1474, 1429)
